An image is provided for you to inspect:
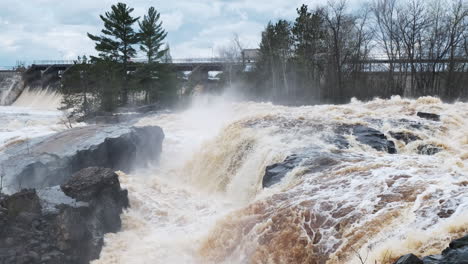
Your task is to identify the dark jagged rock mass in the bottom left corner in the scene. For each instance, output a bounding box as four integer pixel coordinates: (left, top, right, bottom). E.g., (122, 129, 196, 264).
(0, 168, 128, 264)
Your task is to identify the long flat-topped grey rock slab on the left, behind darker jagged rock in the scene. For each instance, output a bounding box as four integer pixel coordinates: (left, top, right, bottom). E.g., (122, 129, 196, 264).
(0, 125, 164, 190)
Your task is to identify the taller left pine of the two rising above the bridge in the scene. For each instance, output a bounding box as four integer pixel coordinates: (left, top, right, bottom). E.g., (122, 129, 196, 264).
(88, 3, 139, 104)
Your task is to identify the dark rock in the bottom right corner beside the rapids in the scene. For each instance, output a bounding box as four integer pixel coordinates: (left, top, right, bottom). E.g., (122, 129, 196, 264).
(394, 235, 468, 264)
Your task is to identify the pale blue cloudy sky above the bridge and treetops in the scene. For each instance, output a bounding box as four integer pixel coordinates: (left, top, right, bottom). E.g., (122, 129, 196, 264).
(0, 0, 357, 66)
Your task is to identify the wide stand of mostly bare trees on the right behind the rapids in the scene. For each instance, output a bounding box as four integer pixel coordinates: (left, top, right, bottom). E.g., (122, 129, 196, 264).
(238, 0, 468, 104)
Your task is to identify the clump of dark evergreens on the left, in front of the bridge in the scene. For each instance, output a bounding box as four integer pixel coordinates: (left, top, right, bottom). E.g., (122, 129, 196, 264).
(61, 3, 179, 116)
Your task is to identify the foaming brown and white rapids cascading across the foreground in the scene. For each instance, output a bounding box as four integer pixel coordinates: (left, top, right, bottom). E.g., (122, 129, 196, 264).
(94, 97, 468, 264)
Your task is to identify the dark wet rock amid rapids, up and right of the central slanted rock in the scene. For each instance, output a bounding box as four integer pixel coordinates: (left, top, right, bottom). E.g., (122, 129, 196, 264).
(335, 125, 397, 154)
